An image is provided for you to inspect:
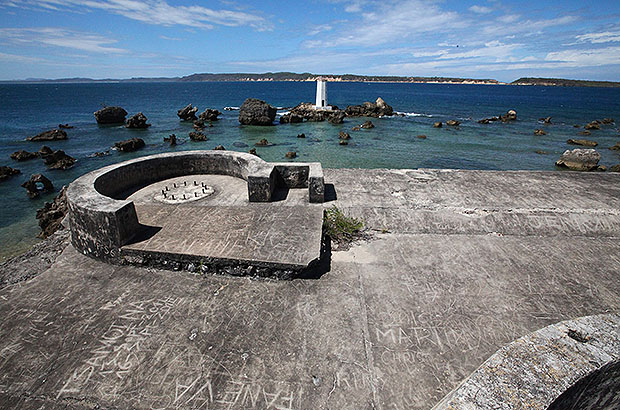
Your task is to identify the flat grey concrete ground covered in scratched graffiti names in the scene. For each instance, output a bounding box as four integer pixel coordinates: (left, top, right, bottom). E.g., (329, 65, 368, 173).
(0, 170, 620, 409)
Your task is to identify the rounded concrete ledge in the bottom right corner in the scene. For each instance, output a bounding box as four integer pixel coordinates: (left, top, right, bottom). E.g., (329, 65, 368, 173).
(433, 314, 620, 410)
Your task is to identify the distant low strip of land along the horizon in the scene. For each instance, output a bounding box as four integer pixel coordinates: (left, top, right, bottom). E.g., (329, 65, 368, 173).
(0, 72, 620, 88)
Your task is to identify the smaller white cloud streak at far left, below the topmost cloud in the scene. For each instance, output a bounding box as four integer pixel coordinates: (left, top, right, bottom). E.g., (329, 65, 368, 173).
(0, 27, 128, 54)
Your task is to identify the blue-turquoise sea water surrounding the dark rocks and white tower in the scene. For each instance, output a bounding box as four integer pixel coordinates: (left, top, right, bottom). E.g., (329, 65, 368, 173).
(0, 82, 620, 258)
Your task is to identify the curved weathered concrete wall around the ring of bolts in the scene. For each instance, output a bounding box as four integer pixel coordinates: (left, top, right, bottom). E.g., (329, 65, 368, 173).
(67, 151, 324, 261)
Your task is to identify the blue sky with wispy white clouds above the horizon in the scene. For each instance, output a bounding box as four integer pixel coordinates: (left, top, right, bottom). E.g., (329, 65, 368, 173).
(0, 0, 620, 81)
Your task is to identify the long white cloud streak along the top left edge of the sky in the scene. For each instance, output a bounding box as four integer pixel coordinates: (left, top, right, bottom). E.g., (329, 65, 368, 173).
(5, 0, 272, 30)
